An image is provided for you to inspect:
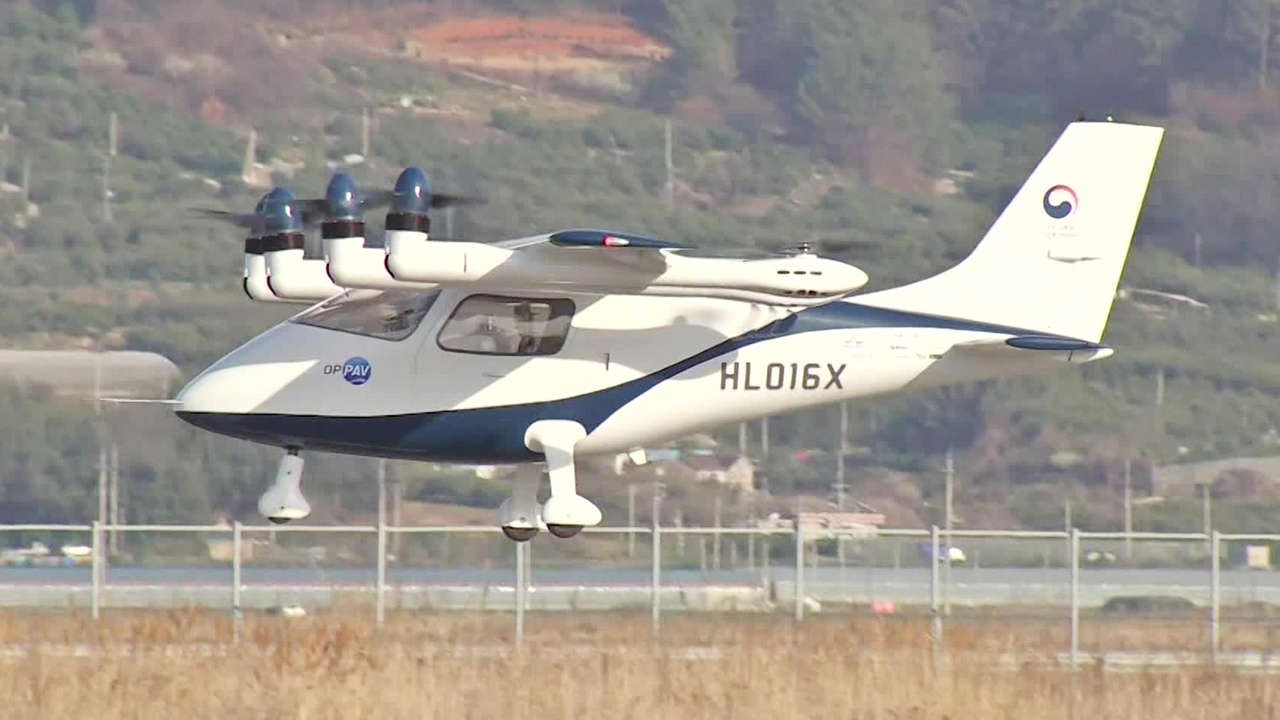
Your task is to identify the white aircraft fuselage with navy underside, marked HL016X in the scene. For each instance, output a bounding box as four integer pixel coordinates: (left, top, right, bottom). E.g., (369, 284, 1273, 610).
(179, 287, 1062, 462)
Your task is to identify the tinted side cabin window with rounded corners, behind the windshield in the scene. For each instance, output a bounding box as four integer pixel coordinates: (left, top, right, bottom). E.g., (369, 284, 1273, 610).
(438, 295, 573, 355)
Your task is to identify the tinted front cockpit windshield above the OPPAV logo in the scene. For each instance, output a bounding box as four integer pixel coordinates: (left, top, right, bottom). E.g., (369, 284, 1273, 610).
(293, 290, 440, 340)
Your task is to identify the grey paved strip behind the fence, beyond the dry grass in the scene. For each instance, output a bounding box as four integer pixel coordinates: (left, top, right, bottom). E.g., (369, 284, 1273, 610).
(0, 566, 1280, 610)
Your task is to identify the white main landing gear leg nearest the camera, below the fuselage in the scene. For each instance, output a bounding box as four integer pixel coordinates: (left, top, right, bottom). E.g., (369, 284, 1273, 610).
(525, 420, 602, 538)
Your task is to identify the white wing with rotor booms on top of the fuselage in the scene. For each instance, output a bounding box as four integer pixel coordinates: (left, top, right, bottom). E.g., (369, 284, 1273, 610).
(262, 225, 868, 307)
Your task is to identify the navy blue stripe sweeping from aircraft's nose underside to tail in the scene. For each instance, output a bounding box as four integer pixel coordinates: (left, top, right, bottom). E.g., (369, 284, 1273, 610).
(178, 302, 1084, 464)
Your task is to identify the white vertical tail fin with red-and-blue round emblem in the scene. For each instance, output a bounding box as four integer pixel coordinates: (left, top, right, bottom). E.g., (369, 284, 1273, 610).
(855, 122, 1165, 342)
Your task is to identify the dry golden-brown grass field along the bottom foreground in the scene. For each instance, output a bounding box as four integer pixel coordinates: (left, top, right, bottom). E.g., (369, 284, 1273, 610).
(0, 611, 1280, 720)
